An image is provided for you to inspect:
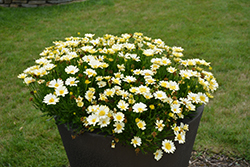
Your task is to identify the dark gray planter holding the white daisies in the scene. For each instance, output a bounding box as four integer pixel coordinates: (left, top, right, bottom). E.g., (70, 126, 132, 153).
(58, 105, 204, 167)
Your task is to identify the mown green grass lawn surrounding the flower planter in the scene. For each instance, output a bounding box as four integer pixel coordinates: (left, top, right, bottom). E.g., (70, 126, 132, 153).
(0, 0, 250, 167)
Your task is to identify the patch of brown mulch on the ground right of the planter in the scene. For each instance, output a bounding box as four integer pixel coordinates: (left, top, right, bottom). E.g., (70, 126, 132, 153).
(188, 151, 250, 167)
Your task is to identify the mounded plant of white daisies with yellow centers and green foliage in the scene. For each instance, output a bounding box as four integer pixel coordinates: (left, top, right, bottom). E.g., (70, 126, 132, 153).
(18, 33, 218, 166)
